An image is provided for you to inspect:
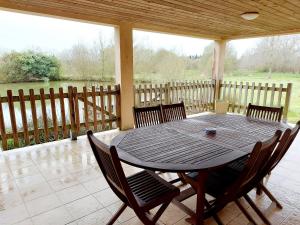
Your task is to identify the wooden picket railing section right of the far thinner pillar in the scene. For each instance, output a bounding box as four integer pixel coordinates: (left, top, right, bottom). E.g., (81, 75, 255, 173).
(217, 81, 292, 121)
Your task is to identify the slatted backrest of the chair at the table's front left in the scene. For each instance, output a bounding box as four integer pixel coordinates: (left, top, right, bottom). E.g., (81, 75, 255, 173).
(87, 130, 135, 204)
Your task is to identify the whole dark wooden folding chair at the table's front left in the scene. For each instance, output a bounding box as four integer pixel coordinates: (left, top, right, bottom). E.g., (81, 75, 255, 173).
(87, 131, 179, 225)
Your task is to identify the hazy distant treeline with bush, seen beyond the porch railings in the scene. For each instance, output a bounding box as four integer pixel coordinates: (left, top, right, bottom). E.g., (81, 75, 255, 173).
(0, 35, 300, 82)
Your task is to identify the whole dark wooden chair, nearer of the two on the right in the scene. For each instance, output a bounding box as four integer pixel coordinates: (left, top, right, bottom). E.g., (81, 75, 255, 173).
(184, 131, 282, 224)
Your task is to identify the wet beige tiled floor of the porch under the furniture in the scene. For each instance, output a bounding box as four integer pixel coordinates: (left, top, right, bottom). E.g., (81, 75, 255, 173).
(0, 130, 300, 225)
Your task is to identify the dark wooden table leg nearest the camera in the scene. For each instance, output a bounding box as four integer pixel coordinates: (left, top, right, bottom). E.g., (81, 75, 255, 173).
(186, 171, 207, 225)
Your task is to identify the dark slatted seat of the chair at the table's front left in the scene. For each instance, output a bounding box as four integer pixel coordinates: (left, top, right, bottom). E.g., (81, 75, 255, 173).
(127, 170, 180, 209)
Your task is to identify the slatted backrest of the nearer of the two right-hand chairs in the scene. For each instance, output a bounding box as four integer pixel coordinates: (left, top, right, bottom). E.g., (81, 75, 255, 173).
(224, 130, 282, 201)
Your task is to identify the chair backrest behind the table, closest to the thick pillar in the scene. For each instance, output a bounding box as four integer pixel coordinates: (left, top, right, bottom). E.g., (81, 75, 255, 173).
(133, 105, 163, 128)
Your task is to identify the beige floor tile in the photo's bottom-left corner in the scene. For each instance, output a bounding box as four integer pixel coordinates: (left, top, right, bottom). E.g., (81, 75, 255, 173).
(0, 204, 29, 225)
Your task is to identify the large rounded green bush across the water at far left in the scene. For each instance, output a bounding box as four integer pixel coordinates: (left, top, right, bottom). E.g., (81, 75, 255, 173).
(0, 51, 60, 82)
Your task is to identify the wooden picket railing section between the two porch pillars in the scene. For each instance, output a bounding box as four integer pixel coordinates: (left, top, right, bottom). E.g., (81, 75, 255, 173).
(134, 81, 215, 114)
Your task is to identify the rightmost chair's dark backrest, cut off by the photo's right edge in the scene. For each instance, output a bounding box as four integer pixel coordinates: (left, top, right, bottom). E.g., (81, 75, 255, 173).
(266, 121, 300, 173)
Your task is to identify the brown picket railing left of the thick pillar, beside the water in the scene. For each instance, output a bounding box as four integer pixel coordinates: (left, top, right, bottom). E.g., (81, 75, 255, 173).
(0, 85, 120, 150)
